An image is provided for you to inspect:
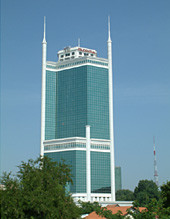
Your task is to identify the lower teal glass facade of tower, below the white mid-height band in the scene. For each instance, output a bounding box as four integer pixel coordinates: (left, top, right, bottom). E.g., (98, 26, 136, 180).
(45, 150, 110, 193)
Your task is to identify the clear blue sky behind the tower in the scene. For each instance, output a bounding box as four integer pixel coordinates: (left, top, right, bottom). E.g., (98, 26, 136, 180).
(1, 0, 170, 190)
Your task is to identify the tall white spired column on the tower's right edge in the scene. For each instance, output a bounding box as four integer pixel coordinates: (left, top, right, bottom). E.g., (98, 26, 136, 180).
(107, 19, 115, 201)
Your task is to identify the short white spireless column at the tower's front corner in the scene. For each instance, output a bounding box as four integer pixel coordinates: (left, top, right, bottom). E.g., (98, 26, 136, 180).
(86, 125, 91, 201)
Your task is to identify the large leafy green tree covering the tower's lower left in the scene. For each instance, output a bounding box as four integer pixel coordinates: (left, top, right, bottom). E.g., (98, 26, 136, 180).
(0, 157, 79, 219)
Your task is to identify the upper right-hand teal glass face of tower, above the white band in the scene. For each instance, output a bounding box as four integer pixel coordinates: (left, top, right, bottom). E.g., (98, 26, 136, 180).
(87, 66, 110, 139)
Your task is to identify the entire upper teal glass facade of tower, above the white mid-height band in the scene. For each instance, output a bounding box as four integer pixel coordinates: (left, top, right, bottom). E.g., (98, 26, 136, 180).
(45, 65, 109, 140)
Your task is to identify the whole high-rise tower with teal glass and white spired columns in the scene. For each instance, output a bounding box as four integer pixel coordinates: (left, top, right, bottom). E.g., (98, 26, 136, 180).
(41, 18, 115, 201)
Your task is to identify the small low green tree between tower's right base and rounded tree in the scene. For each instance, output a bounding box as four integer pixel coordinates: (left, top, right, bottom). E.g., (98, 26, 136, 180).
(116, 189, 134, 201)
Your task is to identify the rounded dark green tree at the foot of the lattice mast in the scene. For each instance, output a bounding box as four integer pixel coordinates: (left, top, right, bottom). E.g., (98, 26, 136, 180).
(134, 180, 160, 206)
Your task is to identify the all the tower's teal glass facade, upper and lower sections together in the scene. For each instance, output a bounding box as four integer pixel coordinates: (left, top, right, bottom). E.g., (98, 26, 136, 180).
(44, 61, 111, 193)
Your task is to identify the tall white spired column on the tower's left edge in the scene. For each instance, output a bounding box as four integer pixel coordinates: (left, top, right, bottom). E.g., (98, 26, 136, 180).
(40, 17, 47, 156)
